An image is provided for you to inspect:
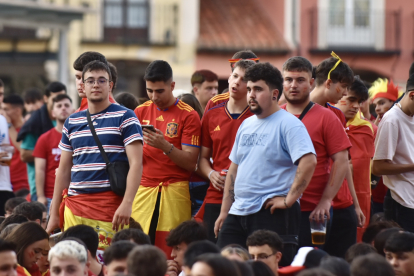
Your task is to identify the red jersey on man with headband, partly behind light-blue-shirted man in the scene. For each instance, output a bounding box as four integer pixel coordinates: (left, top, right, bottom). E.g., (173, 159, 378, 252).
(201, 101, 253, 204)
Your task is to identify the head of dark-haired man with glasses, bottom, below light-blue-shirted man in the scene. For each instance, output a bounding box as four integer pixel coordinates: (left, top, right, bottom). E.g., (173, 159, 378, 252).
(246, 230, 283, 275)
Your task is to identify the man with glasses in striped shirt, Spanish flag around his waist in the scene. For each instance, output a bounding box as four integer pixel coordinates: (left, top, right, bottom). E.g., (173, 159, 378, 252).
(47, 61, 143, 252)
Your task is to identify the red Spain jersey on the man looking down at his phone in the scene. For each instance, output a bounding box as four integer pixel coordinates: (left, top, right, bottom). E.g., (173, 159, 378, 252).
(135, 99, 201, 187)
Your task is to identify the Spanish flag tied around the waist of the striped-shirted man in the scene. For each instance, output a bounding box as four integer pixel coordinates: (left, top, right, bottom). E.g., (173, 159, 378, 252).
(60, 190, 128, 250)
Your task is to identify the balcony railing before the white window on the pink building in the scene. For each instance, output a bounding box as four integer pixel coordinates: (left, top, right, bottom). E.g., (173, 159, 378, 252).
(309, 8, 401, 53)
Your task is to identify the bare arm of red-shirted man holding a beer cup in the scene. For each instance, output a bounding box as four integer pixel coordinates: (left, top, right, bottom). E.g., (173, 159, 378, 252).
(309, 150, 348, 219)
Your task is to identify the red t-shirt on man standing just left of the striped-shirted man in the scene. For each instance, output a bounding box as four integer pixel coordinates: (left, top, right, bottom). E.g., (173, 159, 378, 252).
(33, 128, 62, 198)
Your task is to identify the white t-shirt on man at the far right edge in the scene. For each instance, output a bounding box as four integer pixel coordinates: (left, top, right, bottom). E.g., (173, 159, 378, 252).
(374, 105, 414, 209)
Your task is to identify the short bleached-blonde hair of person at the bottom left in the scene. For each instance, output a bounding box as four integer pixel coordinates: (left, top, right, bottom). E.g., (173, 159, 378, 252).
(48, 240, 88, 264)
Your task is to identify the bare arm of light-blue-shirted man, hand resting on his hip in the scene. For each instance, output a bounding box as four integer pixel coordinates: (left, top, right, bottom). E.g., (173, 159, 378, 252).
(265, 153, 316, 214)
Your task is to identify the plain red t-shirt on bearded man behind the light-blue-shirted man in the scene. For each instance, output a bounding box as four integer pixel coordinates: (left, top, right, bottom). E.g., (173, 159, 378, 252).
(281, 104, 351, 211)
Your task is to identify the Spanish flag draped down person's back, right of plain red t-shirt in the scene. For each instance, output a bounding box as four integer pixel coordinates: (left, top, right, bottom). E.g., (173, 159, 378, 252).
(346, 112, 375, 242)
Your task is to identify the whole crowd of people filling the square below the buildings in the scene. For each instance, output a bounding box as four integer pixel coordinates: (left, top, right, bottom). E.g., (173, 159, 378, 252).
(0, 50, 414, 276)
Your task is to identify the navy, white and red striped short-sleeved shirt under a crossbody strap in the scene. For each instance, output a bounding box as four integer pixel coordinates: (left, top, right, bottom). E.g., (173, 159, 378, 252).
(59, 104, 142, 195)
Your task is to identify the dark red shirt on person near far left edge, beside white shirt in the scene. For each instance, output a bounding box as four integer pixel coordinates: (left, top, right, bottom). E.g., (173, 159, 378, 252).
(10, 128, 30, 192)
